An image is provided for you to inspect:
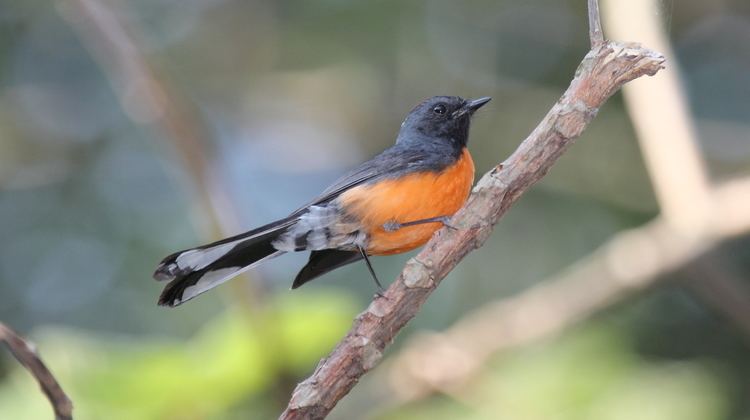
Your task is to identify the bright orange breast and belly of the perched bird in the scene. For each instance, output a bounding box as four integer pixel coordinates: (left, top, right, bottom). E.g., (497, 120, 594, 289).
(339, 149, 474, 255)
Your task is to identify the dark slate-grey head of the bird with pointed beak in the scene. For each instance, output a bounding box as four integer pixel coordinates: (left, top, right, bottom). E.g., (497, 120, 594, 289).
(396, 96, 490, 148)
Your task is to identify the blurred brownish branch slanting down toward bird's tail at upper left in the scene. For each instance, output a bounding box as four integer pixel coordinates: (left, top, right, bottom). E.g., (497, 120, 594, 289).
(56, 0, 266, 306)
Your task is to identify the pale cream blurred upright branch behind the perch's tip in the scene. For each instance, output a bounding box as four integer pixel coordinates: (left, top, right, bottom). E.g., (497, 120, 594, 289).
(603, 0, 712, 232)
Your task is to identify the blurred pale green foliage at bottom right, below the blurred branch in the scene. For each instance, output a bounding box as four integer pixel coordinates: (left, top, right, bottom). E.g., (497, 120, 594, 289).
(379, 323, 728, 420)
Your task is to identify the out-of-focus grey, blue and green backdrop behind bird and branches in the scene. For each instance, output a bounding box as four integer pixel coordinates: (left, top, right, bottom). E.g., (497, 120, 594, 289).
(0, 0, 750, 420)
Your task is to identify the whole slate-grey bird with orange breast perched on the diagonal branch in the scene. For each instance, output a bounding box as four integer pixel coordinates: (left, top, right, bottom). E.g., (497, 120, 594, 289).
(154, 96, 491, 307)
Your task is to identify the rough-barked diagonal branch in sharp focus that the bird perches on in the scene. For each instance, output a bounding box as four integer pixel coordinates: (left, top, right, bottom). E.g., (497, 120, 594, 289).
(280, 42, 664, 419)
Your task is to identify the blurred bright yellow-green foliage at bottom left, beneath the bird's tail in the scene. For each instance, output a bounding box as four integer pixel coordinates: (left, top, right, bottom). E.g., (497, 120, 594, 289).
(0, 292, 354, 420)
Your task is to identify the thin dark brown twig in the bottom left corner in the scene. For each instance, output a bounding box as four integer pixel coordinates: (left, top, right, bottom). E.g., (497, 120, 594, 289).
(0, 322, 73, 420)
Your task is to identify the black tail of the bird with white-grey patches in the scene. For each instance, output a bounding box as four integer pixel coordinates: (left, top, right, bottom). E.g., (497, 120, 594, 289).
(154, 217, 296, 306)
